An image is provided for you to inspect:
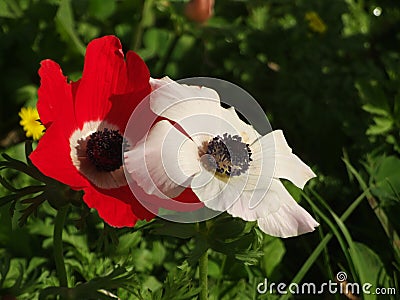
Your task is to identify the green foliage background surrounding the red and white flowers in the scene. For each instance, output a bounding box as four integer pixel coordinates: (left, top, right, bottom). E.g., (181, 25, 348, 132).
(0, 0, 400, 299)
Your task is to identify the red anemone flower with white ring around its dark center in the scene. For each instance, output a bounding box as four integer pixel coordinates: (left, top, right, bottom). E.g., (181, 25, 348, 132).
(30, 36, 154, 227)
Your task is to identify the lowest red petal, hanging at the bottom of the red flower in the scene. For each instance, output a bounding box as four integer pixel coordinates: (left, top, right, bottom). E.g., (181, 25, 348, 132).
(83, 186, 154, 227)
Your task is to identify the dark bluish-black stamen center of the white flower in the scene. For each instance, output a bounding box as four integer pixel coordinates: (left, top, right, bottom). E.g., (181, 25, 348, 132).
(205, 133, 252, 176)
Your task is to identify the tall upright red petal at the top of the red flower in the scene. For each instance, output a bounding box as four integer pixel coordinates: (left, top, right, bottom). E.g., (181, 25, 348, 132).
(75, 36, 125, 128)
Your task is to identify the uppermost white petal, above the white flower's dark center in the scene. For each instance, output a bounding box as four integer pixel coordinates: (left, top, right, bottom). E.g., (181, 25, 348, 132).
(150, 77, 260, 146)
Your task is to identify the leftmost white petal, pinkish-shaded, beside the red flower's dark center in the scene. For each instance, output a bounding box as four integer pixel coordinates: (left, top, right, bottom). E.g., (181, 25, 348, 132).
(124, 121, 200, 198)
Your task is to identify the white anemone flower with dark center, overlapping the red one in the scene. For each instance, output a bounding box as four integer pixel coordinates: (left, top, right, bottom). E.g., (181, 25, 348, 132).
(125, 77, 319, 237)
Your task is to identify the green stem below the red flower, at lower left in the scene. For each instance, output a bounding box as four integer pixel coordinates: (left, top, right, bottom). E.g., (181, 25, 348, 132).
(53, 205, 69, 287)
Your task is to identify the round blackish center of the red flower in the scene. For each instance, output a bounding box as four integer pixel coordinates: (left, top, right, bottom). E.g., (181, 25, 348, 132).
(86, 128, 123, 172)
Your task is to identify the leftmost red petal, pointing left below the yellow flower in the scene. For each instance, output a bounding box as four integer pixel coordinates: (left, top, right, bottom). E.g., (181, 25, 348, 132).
(29, 120, 89, 190)
